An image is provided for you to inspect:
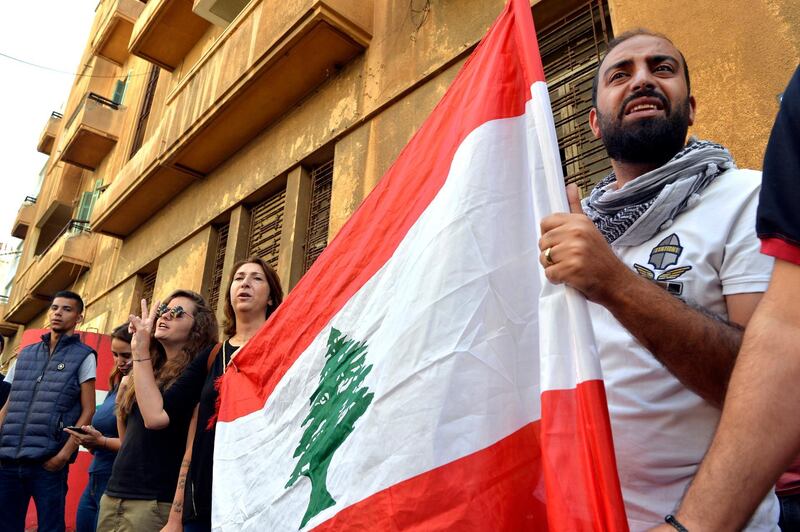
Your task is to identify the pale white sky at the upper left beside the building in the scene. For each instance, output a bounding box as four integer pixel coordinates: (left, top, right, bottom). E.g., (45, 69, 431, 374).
(0, 0, 99, 243)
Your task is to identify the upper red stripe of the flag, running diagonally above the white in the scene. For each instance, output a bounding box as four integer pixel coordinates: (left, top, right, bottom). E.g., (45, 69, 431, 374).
(219, 0, 544, 421)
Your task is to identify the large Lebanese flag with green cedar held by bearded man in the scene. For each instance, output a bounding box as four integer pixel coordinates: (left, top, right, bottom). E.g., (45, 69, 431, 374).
(212, 0, 627, 531)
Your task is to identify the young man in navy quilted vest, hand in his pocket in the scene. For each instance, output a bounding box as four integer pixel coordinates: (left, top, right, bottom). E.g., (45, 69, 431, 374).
(0, 291, 97, 532)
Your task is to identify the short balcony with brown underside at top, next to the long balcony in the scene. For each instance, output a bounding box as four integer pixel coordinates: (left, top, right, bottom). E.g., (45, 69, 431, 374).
(128, 0, 209, 72)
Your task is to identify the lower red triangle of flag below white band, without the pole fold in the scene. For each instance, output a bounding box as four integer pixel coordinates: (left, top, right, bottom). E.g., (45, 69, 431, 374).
(314, 421, 547, 532)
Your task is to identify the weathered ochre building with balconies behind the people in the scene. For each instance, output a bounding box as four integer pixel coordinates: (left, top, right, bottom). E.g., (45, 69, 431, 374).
(0, 0, 800, 364)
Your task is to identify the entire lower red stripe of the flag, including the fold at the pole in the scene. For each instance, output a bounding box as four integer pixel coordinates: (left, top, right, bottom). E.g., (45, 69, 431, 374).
(314, 381, 628, 532)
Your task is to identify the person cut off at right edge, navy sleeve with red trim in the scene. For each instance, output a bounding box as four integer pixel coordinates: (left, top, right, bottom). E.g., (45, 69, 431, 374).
(658, 67, 800, 532)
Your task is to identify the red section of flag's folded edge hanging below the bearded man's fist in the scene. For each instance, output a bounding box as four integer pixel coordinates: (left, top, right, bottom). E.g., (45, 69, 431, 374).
(541, 381, 628, 531)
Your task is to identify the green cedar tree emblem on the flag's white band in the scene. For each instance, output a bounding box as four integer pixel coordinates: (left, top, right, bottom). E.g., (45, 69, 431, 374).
(285, 328, 375, 528)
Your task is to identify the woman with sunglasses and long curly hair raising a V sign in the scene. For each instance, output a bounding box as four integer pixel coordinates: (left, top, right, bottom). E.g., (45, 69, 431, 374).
(98, 290, 218, 532)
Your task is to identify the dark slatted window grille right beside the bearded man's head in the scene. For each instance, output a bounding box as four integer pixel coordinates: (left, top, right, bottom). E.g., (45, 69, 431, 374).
(537, 0, 613, 194)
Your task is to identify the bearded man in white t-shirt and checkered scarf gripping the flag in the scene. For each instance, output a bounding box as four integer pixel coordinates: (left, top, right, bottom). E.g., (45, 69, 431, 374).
(540, 30, 778, 531)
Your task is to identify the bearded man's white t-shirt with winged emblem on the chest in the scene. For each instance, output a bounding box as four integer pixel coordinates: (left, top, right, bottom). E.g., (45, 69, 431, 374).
(589, 170, 778, 531)
